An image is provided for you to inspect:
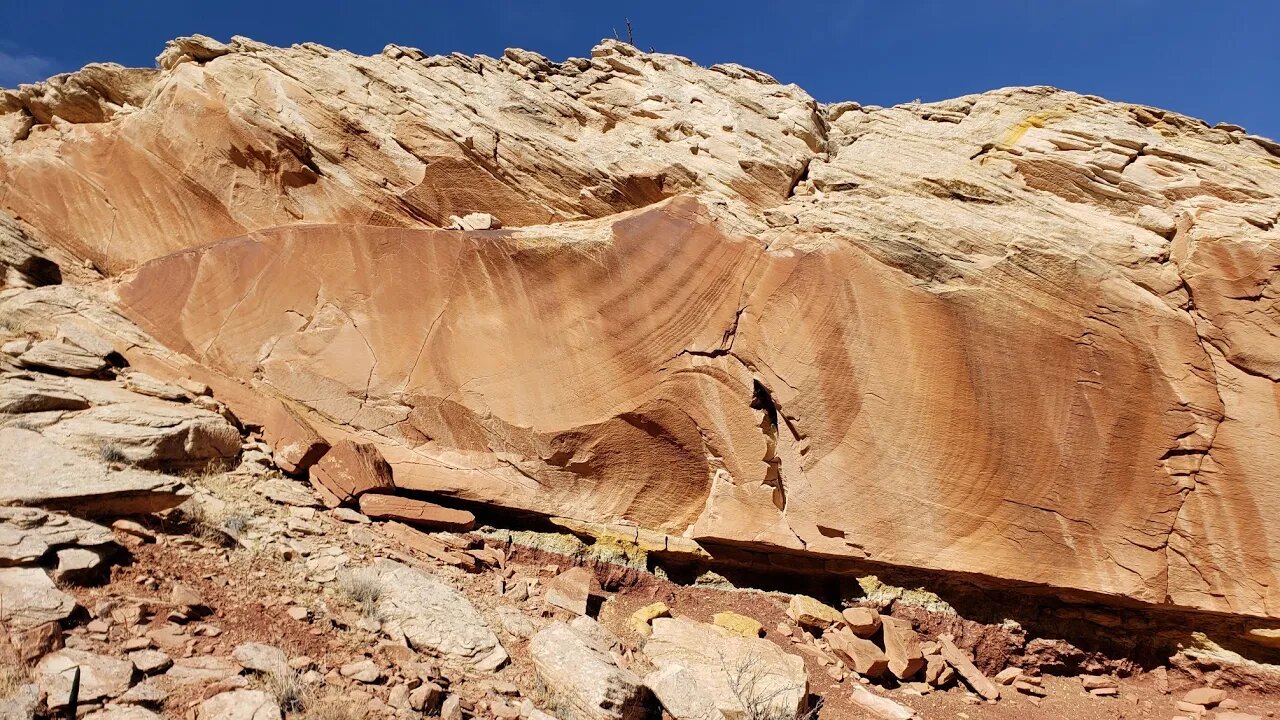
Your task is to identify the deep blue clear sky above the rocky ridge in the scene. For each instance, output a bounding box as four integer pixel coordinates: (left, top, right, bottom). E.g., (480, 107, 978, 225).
(0, 0, 1280, 137)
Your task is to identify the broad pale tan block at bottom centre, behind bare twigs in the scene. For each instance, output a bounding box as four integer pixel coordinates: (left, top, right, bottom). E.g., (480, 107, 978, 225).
(644, 618, 809, 720)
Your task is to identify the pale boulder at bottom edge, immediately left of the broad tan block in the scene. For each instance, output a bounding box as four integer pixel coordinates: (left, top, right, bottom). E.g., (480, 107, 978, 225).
(529, 618, 649, 720)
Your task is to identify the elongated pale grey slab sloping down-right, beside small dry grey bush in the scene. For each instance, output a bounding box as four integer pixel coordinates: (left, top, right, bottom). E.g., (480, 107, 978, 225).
(374, 560, 508, 670)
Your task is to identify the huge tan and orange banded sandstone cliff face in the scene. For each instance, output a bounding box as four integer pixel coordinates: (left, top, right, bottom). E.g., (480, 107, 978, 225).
(0, 40, 1280, 616)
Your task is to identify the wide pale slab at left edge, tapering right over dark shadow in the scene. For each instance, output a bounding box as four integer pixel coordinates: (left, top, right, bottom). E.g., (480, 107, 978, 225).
(0, 427, 191, 518)
